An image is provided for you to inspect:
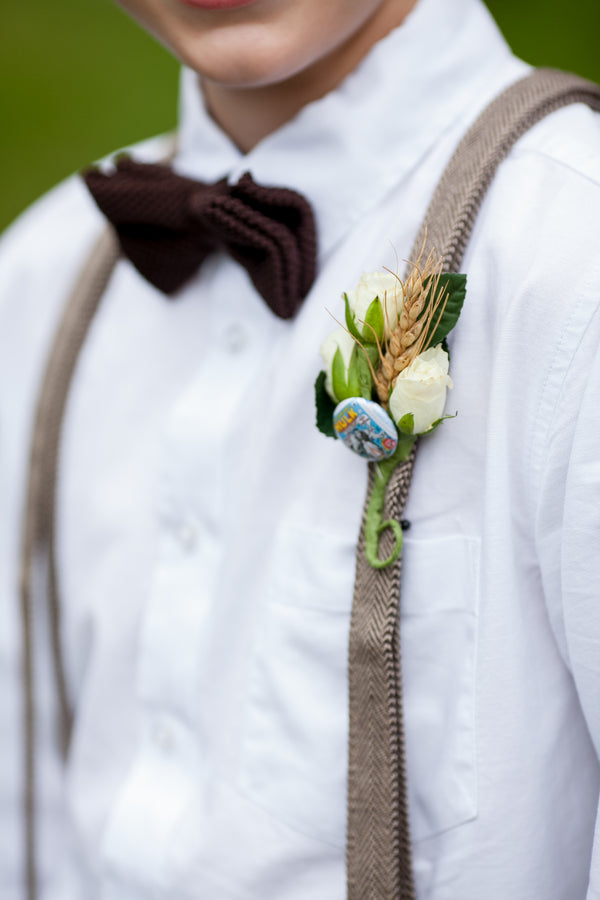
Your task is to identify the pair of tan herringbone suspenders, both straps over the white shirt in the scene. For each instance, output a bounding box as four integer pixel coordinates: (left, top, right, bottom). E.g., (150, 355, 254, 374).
(20, 70, 600, 900)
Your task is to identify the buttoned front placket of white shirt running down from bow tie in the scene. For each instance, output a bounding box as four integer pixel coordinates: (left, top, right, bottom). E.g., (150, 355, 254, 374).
(99, 258, 270, 897)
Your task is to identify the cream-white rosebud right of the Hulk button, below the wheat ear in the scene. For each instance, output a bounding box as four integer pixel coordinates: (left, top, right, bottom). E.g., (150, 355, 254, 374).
(389, 346, 453, 434)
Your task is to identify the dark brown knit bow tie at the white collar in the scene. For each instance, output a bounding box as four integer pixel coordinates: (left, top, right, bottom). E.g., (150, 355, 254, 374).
(83, 158, 316, 319)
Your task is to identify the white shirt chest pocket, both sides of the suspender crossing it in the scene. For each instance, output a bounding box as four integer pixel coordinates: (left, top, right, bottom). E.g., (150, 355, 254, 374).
(239, 528, 478, 847)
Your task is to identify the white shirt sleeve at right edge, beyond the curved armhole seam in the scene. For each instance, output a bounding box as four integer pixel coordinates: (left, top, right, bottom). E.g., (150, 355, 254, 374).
(536, 273, 600, 900)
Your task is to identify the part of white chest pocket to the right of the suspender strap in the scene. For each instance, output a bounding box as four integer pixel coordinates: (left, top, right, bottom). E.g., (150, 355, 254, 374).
(400, 537, 480, 841)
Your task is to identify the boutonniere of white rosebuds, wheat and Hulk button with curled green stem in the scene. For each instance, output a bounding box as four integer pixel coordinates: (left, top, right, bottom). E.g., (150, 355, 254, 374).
(315, 246, 467, 569)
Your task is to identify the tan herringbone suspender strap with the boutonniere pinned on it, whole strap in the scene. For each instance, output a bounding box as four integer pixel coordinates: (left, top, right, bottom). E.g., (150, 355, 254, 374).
(346, 70, 600, 900)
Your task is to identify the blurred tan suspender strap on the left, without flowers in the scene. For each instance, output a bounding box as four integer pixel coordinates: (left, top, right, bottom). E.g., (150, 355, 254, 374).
(20, 229, 119, 900)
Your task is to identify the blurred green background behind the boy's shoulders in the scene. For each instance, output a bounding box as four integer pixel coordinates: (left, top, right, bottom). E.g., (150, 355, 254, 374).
(0, 0, 600, 228)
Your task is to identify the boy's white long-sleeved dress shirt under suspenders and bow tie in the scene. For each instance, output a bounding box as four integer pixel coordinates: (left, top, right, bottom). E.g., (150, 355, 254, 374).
(0, 0, 600, 900)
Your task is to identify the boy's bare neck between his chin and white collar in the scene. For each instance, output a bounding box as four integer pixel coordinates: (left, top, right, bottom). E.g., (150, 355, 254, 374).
(200, 0, 416, 153)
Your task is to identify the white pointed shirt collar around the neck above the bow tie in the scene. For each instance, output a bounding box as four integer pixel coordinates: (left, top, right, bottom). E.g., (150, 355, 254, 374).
(174, 0, 510, 255)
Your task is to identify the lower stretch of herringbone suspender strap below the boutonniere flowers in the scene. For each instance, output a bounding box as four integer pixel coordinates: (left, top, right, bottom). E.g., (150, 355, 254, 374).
(346, 447, 416, 900)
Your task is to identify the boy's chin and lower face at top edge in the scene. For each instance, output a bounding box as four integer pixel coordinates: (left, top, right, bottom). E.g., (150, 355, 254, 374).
(118, 0, 416, 89)
